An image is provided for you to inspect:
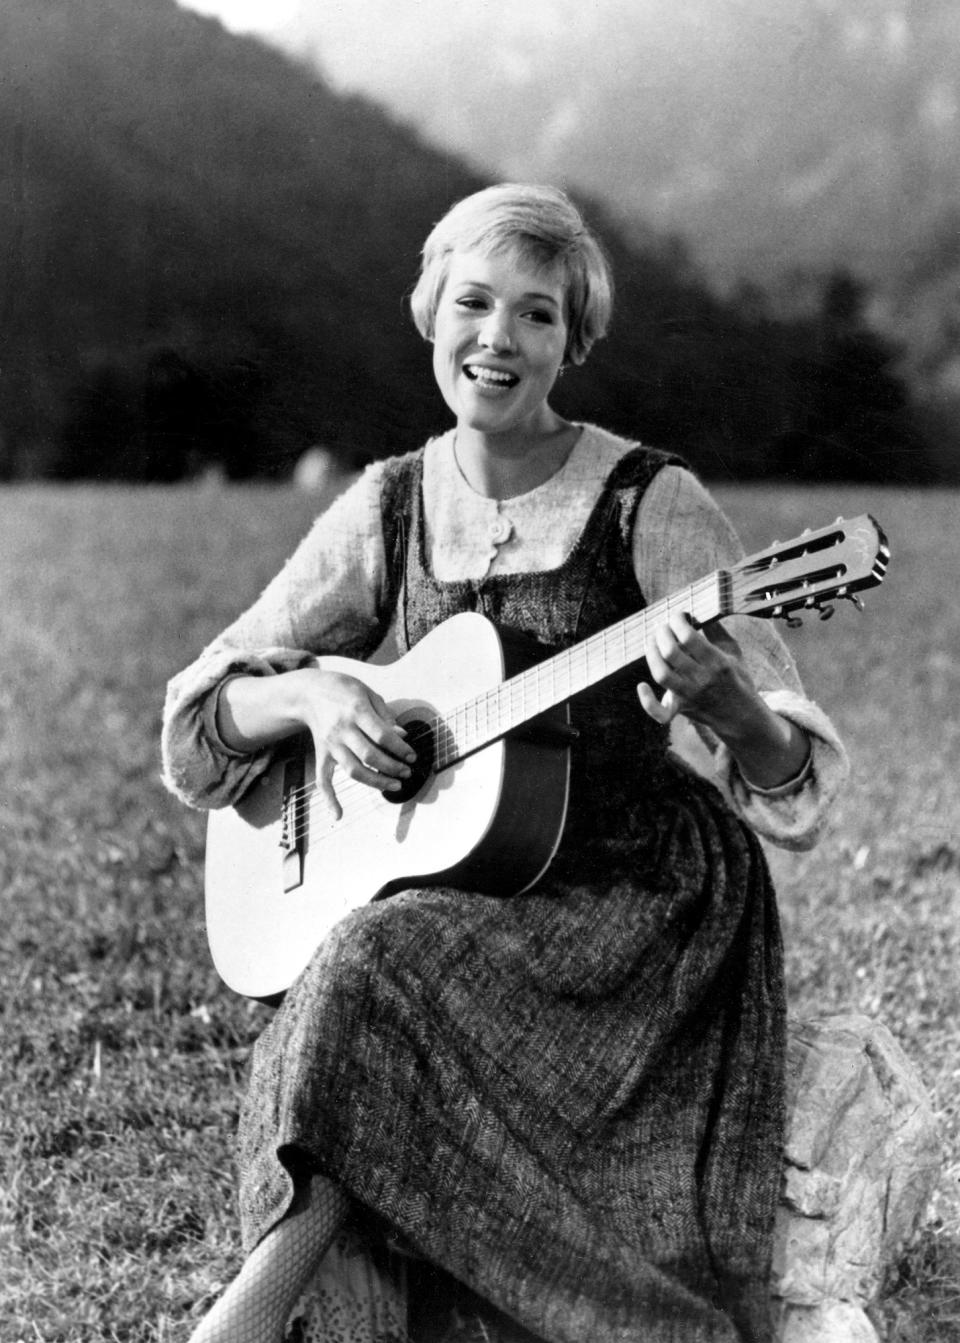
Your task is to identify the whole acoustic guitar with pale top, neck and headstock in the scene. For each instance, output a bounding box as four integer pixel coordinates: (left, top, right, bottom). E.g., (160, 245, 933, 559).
(205, 514, 890, 1002)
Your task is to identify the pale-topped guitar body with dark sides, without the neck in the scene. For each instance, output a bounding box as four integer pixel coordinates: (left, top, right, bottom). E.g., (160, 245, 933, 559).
(205, 612, 569, 1001)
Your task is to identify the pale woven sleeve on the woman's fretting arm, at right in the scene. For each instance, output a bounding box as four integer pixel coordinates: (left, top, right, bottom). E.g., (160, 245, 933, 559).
(634, 466, 850, 849)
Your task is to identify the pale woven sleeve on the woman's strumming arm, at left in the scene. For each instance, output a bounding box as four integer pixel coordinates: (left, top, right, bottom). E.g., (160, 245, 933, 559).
(161, 466, 389, 807)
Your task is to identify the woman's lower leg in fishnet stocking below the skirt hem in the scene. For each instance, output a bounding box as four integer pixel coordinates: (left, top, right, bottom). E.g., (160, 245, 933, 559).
(191, 1175, 349, 1343)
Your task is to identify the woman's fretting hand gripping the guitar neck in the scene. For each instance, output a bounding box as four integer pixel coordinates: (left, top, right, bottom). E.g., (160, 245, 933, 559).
(638, 611, 763, 737)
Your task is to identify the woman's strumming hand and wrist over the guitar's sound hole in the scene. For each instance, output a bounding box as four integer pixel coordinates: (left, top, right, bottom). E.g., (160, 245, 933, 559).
(218, 667, 416, 819)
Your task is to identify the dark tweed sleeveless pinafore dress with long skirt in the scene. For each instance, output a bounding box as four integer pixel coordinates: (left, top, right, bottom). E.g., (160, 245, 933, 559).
(240, 449, 784, 1343)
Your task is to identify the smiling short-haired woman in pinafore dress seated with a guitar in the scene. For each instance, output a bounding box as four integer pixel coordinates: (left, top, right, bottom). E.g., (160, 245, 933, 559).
(164, 185, 847, 1343)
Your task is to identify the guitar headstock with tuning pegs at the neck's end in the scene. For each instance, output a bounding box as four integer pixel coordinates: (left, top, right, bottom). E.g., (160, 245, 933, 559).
(722, 513, 890, 624)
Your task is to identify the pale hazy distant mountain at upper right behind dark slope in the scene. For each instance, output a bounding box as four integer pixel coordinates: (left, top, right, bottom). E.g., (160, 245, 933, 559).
(285, 0, 960, 392)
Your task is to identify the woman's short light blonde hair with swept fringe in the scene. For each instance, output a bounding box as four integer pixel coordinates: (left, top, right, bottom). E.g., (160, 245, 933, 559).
(410, 183, 614, 364)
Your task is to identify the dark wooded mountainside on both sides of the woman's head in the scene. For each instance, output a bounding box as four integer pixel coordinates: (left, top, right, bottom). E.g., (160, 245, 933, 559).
(0, 0, 929, 479)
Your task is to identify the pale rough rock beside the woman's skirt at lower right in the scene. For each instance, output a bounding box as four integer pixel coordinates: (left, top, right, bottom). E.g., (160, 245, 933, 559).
(772, 1015, 941, 1343)
